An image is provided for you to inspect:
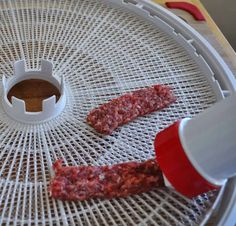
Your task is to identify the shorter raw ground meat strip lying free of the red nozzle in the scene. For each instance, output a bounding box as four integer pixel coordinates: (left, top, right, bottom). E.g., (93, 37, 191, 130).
(87, 85, 176, 135)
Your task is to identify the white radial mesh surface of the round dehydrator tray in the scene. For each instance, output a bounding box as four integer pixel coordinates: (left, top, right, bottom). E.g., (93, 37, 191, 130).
(0, 0, 217, 225)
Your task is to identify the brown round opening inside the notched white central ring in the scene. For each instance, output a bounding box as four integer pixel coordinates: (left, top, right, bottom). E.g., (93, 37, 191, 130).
(7, 79, 61, 112)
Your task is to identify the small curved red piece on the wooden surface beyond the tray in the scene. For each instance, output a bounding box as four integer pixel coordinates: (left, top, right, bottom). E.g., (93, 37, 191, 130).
(166, 2, 206, 21)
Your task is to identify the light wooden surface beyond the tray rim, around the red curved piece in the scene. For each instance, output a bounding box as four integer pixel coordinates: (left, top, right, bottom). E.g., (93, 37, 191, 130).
(152, 0, 236, 75)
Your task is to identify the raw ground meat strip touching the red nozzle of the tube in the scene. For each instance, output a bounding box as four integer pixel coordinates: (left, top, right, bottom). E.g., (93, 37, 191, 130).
(49, 159, 164, 201)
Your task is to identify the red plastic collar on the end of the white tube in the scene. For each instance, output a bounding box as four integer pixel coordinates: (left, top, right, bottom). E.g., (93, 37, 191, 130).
(154, 121, 219, 198)
